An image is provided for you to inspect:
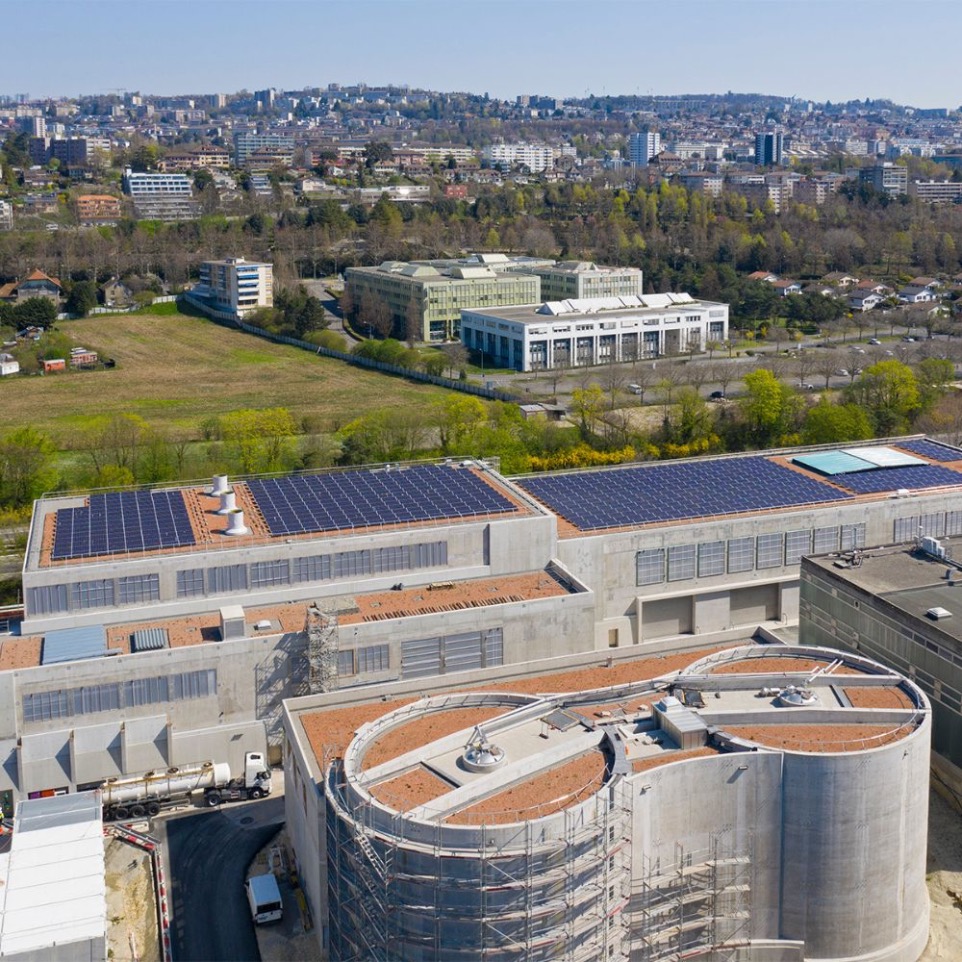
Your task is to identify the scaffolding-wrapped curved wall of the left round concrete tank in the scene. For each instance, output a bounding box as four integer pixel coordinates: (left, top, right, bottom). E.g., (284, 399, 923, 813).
(327, 762, 631, 962)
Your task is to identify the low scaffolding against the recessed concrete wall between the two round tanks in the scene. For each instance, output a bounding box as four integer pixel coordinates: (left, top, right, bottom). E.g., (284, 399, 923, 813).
(632, 833, 753, 962)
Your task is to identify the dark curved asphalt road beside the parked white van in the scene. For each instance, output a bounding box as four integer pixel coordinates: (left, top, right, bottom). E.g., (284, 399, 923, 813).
(157, 796, 284, 962)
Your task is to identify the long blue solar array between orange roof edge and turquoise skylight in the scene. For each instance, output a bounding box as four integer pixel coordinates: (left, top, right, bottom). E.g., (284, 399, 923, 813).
(518, 457, 851, 531)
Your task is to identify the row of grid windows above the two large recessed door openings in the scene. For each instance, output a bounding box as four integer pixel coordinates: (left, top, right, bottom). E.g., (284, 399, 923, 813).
(635, 524, 865, 585)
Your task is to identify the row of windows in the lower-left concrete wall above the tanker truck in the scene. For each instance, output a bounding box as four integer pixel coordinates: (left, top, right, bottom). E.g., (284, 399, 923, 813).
(23, 668, 217, 722)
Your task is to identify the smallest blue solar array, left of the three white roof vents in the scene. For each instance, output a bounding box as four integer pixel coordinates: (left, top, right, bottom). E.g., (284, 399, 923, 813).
(51, 491, 195, 561)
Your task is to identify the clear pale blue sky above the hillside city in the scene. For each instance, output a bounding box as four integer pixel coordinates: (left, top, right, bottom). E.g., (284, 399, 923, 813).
(7, 0, 962, 108)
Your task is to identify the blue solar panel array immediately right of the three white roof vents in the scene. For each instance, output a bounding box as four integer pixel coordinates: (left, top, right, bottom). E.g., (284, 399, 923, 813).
(247, 464, 517, 535)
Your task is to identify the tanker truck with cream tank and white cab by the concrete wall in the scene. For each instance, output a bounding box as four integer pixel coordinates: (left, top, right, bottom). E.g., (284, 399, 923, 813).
(100, 752, 271, 822)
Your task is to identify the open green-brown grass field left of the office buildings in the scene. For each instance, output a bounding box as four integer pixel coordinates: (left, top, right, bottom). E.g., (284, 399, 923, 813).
(0, 314, 445, 448)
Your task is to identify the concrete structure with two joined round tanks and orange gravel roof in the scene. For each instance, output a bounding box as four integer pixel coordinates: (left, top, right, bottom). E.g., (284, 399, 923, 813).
(285, 645, 931, 962)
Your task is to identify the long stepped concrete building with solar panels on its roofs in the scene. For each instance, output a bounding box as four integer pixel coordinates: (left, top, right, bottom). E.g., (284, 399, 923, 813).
(11, 439, 962, 808)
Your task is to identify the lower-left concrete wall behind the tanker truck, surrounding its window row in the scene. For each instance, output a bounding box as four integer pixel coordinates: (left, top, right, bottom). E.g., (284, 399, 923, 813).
(0, 634, 306, 797)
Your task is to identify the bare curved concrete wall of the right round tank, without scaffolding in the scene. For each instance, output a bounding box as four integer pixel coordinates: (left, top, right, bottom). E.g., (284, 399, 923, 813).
(781, 714, 931, 962)
